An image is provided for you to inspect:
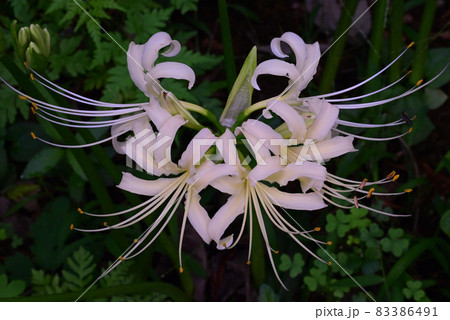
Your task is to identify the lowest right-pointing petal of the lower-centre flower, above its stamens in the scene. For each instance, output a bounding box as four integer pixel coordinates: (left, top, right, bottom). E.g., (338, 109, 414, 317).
(258, 183, 326, 210)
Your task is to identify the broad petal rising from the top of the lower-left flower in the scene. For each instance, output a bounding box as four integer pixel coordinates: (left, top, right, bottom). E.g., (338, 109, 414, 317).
(178, 128, 217, 170)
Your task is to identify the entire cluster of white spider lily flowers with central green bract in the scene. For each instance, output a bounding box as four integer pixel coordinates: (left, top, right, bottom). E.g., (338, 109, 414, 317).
(2, 32, 439, 283)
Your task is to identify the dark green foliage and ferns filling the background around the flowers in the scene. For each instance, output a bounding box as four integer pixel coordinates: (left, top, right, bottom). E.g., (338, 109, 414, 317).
(0, 0, 450, 301)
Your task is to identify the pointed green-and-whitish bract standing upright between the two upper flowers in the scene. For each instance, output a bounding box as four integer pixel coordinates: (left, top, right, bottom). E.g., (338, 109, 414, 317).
(220, 47, 257, 127)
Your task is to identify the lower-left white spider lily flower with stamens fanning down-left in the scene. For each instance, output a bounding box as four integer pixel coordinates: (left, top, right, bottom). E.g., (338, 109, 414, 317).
(71, 126, 232, 272)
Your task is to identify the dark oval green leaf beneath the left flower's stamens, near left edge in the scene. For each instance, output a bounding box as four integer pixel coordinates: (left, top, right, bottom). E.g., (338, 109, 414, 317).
(22, 148, 64, 179)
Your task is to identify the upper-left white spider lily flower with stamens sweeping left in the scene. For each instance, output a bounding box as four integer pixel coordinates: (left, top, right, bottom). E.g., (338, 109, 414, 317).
(0, 32, 202, 148)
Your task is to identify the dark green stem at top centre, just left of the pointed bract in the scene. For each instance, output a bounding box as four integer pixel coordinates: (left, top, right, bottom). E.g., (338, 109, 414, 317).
(217, 0, 236, 92)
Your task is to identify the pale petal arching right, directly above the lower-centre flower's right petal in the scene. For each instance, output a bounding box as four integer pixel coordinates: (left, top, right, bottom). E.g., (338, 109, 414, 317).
(266, 161, 327, 192)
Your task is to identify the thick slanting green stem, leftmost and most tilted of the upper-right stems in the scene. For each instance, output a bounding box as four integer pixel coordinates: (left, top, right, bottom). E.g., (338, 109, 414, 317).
(319, 0, 358, 94)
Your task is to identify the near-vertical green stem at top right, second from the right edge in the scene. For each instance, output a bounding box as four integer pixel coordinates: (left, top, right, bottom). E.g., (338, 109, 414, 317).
(389, 0, 404, 82)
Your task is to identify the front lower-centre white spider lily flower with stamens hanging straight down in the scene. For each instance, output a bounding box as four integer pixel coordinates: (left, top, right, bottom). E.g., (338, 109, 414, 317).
(197, 129, 326, 286)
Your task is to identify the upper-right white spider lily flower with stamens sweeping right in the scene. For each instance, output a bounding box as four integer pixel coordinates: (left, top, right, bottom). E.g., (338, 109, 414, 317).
(250, 32, 447, 141)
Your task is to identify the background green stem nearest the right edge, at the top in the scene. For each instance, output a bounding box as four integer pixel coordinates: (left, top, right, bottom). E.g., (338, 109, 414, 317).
(410, 0, 437, 83)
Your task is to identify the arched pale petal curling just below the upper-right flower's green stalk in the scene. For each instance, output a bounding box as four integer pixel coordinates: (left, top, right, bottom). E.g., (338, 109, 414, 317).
(263, 100, 306, 143)
